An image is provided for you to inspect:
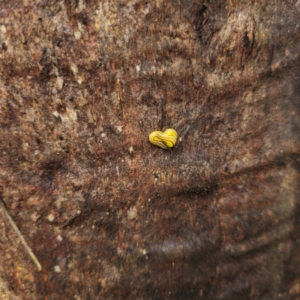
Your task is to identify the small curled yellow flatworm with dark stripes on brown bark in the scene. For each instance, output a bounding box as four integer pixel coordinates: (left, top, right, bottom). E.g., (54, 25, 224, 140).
(149, 128, 178, 149)
